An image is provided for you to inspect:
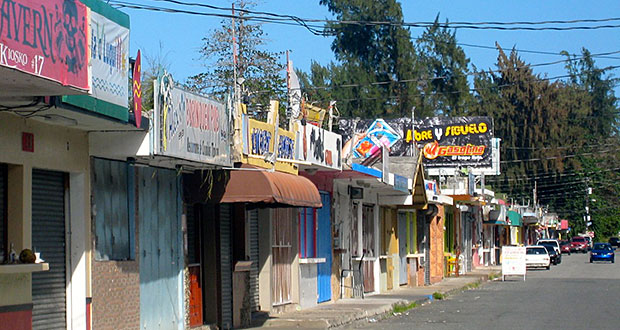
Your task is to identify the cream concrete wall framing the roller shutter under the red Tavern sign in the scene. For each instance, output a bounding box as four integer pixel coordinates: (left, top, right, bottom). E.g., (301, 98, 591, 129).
(0, 113, 91, 328)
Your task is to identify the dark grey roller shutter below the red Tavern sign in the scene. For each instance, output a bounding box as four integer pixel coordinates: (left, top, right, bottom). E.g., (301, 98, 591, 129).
(32, 170, 67, 329)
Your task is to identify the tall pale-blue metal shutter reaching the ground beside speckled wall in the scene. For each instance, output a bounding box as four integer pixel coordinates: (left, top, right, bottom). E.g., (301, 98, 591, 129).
(137, 168, 185, 330)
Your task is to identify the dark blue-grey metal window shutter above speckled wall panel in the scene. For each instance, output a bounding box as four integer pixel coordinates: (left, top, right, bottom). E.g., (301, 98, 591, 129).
(92, 158, 135, 260)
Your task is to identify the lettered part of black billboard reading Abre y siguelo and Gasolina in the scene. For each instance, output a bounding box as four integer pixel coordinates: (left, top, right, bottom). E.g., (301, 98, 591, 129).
(414, 117, 493, 167)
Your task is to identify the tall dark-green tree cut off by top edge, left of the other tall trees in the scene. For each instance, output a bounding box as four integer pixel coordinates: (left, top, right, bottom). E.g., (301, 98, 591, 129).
(320, 0, 418, 118)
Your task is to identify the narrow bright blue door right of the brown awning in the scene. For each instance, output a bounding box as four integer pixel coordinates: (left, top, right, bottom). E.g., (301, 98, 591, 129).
(317, 192, 332, 303)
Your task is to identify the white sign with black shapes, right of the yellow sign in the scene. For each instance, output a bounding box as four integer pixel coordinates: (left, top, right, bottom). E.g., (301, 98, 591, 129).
(297, 124, 342, 170)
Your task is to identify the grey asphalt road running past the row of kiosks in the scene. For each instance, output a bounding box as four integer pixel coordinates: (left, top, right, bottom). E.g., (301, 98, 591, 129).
(349, 251, 620, 330)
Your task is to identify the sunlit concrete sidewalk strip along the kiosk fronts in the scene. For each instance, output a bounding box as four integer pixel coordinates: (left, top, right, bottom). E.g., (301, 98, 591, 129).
(253, 266, 501, 329)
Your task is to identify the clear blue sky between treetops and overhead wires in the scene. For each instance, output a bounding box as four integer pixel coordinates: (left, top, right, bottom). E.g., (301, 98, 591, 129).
(122, 0, 620, 87)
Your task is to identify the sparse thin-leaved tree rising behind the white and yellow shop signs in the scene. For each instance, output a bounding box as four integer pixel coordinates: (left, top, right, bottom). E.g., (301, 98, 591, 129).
(187, 0, 286, 109)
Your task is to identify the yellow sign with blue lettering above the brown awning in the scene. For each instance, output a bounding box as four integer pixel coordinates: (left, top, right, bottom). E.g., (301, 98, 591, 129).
(243, 119, 297, 174)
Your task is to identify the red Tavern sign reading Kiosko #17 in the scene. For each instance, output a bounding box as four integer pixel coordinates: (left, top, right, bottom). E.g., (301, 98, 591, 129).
(0, 0, 90, 90)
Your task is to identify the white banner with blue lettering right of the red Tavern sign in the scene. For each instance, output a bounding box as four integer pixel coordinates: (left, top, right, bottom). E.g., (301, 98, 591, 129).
(90, 11, 129, 108)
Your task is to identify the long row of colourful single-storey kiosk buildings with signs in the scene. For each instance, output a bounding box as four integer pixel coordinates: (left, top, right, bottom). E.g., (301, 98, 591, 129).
(0, 0, 560, 329)
